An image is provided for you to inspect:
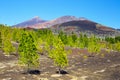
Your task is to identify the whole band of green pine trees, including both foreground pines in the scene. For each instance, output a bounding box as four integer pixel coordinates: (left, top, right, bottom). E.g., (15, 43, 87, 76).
(0, 25, 120, 77)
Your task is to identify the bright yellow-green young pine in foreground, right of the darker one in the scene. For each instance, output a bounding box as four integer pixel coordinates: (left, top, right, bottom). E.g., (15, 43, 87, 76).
(49, 38, 68, 73)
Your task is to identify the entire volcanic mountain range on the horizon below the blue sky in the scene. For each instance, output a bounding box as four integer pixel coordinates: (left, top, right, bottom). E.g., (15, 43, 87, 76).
(15, 16, 120, 35)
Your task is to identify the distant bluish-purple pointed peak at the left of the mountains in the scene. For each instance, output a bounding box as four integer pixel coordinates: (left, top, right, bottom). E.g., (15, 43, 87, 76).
(14, 16, 46, 27)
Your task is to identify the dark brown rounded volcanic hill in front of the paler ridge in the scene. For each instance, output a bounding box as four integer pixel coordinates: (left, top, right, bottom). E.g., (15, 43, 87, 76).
(51, 19, 115, 35)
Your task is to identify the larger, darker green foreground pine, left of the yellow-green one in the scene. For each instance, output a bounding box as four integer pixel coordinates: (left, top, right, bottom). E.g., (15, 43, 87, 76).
(18, 31, 39, 72)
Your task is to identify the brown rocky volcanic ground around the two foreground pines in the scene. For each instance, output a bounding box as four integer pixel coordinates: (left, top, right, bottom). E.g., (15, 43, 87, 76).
(0, 48, 120, 80)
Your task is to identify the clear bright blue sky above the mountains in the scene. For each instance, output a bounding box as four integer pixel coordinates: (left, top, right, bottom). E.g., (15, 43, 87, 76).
(0, 0, 120, 28)
